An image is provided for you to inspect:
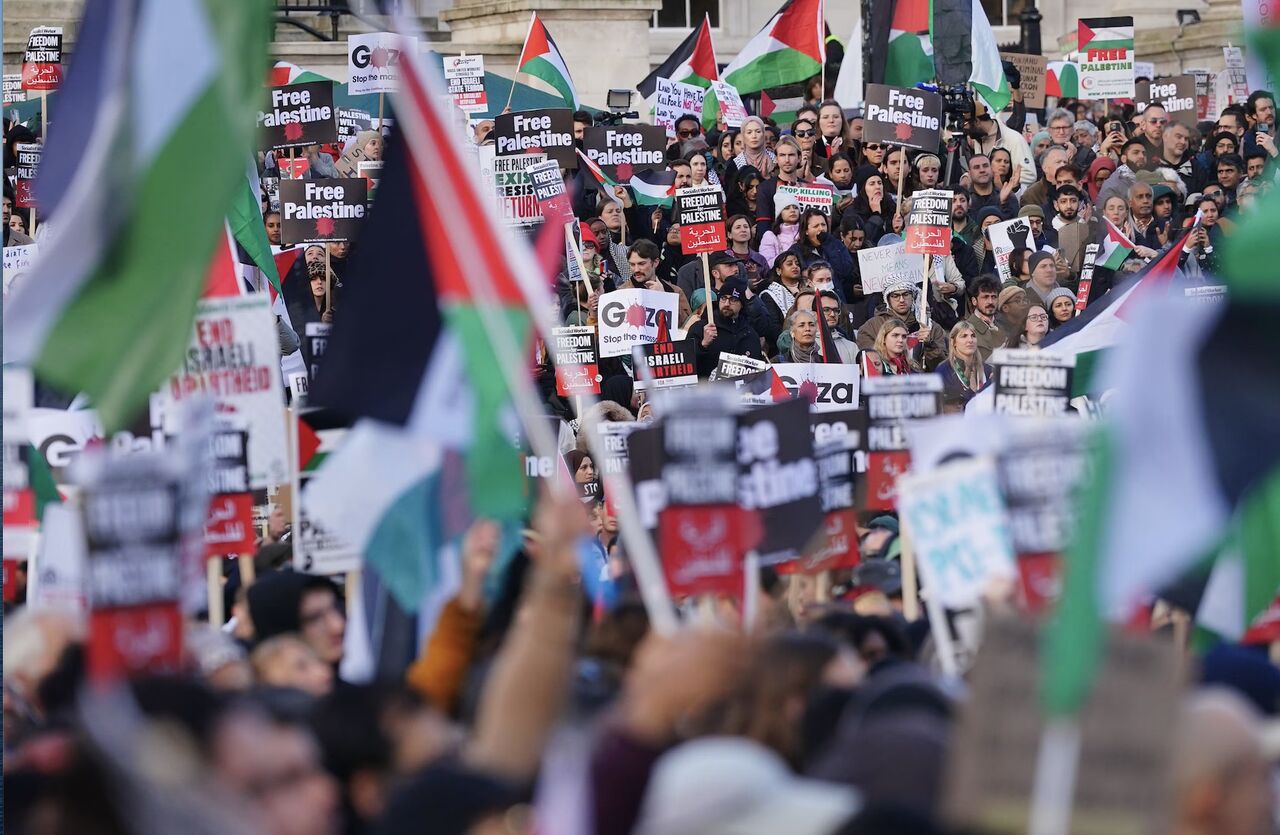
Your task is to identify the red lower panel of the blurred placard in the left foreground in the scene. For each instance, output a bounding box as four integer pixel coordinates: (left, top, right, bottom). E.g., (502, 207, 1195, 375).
(86, 602, 182, 683)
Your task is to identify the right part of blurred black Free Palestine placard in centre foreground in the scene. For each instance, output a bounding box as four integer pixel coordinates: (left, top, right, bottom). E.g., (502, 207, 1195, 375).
(737, 400, 823, 565)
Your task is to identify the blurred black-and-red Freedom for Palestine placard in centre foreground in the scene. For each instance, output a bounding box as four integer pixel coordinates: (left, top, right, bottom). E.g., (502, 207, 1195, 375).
(655, 388, 758, 597)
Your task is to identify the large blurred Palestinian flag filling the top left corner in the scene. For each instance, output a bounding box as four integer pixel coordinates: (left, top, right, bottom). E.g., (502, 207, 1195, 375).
(4, 0, 270, 432)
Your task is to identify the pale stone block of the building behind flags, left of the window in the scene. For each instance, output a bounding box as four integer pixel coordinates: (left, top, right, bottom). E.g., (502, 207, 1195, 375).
(439, 0, 662, 108)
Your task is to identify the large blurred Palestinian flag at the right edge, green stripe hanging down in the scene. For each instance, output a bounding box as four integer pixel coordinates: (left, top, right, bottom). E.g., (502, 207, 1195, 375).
(1043, 178, 1280, 713)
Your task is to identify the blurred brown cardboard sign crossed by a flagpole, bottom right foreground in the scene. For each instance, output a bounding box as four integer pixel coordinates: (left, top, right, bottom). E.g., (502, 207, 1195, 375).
(942, 617, 1181, 835)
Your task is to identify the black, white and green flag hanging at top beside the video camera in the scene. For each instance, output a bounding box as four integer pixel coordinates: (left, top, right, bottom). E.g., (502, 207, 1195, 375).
(932, 0, 1012, 113)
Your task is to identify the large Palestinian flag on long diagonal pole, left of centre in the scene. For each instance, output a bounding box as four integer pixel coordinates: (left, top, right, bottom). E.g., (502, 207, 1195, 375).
(306, 39, 545, 610)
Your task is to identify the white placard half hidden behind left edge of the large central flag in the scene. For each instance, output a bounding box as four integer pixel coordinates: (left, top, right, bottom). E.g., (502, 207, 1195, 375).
(289, 415, 361, 574)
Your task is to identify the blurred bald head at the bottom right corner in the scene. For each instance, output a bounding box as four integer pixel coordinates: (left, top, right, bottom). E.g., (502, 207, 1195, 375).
(1174, 689, 1271, 835)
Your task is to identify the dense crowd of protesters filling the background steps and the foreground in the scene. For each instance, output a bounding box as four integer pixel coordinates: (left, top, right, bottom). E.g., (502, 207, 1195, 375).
(4, 50, 1280, 835)
